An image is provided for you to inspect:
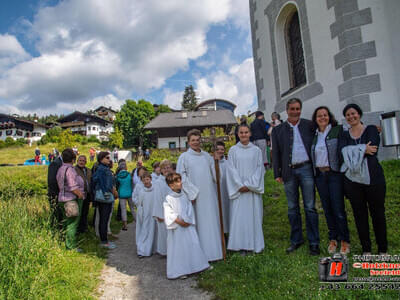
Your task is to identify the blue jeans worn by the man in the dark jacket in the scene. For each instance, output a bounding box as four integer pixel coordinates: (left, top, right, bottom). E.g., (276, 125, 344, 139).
(284, 164, 319, 245)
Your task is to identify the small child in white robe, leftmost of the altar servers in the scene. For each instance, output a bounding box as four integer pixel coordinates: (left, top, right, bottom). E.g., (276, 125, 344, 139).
(133, 171, 155, 257)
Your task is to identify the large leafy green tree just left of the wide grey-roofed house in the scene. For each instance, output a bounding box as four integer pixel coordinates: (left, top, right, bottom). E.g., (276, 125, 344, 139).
(114, 99, 155, 147)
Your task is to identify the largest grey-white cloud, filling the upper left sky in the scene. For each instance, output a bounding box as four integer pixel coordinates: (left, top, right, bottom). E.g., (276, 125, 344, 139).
(0, 0, 232, 110)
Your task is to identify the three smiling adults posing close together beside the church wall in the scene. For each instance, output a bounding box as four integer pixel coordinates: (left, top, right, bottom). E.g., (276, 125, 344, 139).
(272, 98, 388, 255)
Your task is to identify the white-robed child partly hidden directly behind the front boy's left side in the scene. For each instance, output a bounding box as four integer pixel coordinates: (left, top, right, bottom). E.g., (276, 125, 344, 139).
(153, 159, 172, 255)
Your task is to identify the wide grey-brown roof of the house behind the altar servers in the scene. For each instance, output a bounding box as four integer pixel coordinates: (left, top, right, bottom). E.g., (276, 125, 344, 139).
(144, 109, 237, 129)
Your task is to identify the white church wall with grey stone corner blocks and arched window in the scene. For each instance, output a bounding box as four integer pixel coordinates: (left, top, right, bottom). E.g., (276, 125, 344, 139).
(249, 0, 400, 124)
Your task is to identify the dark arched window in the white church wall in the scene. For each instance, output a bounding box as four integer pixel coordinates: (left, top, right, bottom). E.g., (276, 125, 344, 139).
(286, 11, 307, 90)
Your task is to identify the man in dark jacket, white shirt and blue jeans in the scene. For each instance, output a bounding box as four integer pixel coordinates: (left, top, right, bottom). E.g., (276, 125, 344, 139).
(272, 98, 320, 255)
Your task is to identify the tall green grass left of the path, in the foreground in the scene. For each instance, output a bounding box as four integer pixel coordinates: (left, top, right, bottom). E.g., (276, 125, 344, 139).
(0, 166, 128, 299)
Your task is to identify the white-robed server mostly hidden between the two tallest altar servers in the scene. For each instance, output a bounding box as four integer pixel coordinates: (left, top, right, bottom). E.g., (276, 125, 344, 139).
(215, 142, 230, 233)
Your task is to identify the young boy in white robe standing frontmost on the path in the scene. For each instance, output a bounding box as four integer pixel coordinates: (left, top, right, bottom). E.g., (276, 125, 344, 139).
(164, 173, 210, 279)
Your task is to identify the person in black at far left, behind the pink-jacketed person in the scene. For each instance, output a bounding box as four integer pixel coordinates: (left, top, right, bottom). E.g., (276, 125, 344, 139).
(47, 156, 63, 228)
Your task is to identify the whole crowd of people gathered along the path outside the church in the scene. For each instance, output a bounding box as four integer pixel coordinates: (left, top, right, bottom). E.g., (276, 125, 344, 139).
(49, 98, 387, 279)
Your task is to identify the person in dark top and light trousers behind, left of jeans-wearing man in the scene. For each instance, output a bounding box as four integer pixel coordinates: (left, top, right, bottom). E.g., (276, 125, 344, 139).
(250, 111, 271, 166)
